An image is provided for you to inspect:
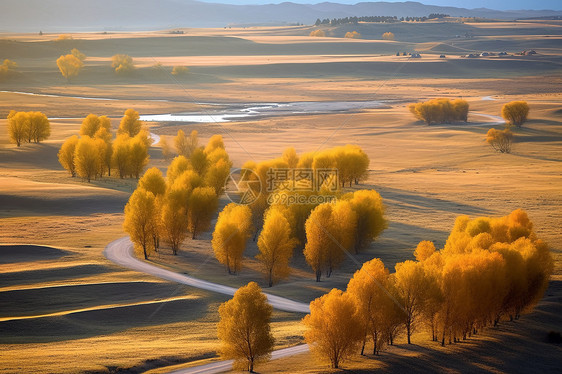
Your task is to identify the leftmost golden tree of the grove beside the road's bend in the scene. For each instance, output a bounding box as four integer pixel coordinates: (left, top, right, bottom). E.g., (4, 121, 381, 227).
(123, 188, 157, 260)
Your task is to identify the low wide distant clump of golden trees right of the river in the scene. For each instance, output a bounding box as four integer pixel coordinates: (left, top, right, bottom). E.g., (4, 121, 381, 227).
(408, 99, 468, 125)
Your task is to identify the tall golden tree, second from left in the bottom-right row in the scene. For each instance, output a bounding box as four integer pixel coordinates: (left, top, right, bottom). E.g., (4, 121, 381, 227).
(347, 258, 393, 355)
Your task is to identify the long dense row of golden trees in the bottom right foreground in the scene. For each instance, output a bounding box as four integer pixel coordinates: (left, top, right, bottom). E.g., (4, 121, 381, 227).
(303, 209, 553, 367)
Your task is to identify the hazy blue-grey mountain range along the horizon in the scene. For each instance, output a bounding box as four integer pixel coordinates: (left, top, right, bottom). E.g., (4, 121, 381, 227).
(0, 0, 562, 31)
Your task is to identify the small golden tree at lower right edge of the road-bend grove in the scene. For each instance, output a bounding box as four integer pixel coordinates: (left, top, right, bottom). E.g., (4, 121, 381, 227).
(187, 187, 219, 239)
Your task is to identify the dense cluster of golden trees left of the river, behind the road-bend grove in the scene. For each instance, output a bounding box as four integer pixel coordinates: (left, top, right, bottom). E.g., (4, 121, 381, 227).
(58, 109, 151, 182)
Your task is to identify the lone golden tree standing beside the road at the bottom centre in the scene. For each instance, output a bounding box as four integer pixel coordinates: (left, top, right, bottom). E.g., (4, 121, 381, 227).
(217, 282, 275, 372)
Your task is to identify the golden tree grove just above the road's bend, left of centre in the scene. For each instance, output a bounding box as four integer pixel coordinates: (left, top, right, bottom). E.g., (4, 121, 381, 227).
(123, 132, 231, 259)
